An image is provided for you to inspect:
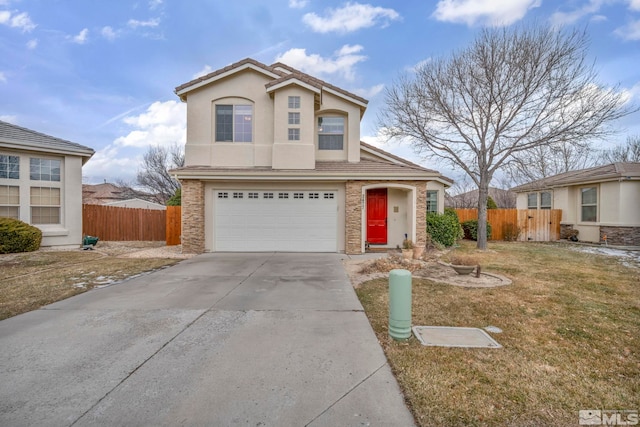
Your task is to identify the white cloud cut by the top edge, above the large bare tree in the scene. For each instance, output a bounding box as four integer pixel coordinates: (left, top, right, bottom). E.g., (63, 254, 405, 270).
(432, 0, 541, 26)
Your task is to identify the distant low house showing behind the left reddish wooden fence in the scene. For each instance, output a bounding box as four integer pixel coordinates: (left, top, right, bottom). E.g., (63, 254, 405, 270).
(82, 182, 166, 209)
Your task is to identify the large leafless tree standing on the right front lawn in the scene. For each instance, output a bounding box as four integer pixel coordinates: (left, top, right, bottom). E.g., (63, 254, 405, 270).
(380, 26, 631, 249)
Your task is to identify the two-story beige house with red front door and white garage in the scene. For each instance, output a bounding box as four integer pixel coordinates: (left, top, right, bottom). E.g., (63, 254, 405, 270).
(171, 59, 452, 254)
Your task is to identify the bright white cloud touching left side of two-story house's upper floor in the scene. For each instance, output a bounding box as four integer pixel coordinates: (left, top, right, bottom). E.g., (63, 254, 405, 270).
(114, 101, 187, 147)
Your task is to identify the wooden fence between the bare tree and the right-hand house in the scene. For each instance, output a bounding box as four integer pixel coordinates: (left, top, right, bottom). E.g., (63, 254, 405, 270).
(456, 209, 562, 242)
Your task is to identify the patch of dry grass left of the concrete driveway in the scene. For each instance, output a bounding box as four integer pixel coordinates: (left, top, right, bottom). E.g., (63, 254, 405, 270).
(0, 242, 179, 320)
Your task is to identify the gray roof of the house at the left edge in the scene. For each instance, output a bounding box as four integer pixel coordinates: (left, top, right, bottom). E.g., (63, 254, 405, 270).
(0, 121, 95, 158)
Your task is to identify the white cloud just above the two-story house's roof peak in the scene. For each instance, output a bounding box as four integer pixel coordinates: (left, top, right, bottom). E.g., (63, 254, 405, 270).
(275, 45, 367, 81)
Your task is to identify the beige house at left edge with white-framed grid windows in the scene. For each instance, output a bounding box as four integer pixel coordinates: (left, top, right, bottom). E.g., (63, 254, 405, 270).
(0, 121, 94, 246)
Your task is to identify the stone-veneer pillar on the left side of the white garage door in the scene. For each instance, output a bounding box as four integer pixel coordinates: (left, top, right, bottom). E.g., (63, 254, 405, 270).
(181, 179, 204, 254)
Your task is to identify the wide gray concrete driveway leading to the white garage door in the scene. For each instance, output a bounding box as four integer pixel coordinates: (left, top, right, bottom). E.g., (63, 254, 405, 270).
(0, 253, 413, 426)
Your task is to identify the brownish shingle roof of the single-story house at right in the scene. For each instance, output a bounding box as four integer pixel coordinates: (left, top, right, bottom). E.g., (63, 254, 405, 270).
(511, 162, 640, 193)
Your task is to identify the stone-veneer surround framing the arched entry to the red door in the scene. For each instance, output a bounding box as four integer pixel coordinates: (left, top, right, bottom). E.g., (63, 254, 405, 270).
(344, 181, 427, 255)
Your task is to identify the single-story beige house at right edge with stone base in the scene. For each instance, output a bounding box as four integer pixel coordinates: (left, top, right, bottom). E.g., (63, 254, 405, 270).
(511, 163, 640, 246)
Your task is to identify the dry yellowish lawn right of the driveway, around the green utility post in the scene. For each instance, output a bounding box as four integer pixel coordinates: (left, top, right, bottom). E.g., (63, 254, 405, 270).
(357, 242, 640, 426)
